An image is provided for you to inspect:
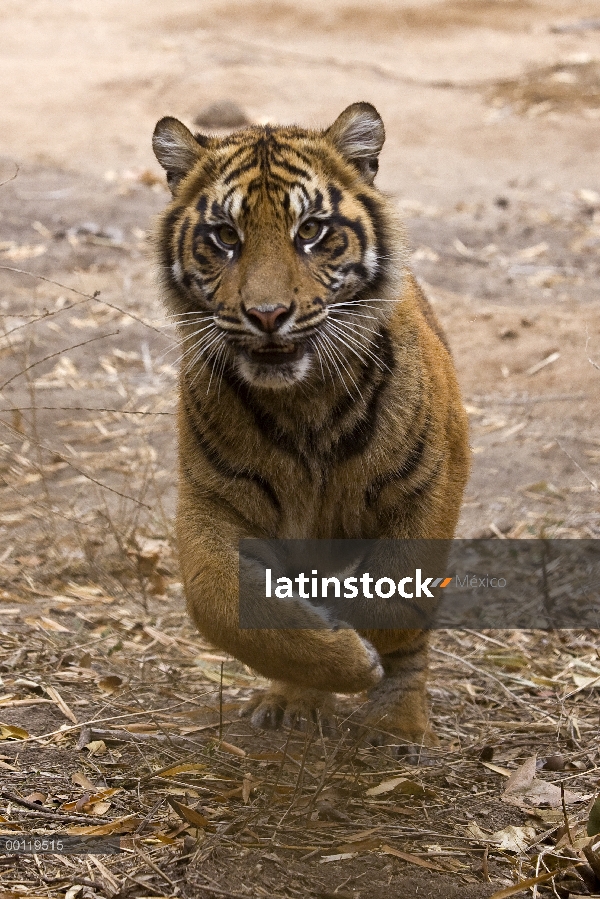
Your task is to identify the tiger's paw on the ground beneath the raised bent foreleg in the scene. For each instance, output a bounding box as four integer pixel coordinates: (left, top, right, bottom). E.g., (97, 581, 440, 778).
(241, 681, 335, 735)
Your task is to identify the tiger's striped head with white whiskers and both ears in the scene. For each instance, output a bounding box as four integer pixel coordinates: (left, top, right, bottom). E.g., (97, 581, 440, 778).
(153, 103, 404, 388)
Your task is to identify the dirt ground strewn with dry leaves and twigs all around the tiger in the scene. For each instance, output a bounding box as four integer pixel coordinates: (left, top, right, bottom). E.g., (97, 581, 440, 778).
(0, 0, 600, 899)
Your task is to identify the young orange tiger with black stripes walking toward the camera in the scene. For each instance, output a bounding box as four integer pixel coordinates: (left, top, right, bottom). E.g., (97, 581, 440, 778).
(153, 103, 469, 742)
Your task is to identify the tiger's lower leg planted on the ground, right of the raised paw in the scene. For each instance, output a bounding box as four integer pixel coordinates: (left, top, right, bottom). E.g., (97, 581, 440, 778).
(362, 633, 437, 757)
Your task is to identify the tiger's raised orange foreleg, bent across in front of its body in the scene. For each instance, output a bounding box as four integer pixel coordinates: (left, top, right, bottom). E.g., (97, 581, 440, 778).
(177, 494, 383, 704)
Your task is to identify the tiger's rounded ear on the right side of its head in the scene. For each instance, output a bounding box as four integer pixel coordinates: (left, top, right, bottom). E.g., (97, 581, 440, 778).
(325, 103, 385, 184)
